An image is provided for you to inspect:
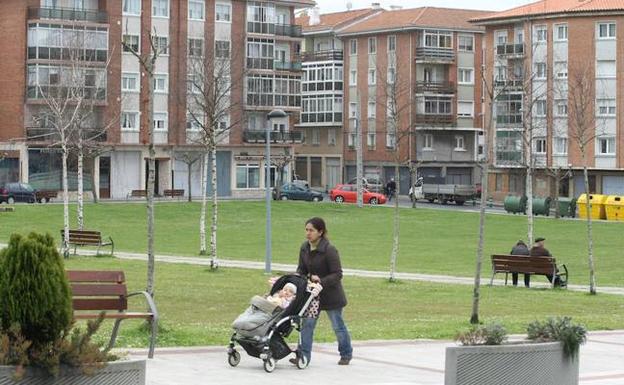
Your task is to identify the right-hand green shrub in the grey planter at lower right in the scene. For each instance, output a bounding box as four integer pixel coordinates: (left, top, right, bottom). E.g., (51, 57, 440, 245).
(527, 317, 587, 358)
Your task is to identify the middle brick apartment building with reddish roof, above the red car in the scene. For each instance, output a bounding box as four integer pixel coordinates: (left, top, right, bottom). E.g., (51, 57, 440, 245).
(337, 7, 485, 194)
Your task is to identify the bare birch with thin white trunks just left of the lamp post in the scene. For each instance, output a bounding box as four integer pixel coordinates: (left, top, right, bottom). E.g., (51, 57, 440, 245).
(186, 46, 246, 268)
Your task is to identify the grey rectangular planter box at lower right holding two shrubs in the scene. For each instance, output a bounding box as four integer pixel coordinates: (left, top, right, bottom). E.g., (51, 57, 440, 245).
(444, 342, 579, 385)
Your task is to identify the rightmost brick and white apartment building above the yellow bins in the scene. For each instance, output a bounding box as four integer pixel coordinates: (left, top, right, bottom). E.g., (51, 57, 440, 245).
(473, 0, 624, 199)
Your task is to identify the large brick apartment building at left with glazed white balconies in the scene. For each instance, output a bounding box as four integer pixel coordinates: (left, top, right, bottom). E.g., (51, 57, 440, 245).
(0, 0, 314, 199)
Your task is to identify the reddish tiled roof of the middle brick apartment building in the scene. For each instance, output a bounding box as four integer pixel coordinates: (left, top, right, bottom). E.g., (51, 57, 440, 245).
(339, 7, 490, 34)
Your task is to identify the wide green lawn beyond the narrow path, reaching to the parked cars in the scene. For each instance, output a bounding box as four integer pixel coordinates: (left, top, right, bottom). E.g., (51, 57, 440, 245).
(0, 201, 624, 286)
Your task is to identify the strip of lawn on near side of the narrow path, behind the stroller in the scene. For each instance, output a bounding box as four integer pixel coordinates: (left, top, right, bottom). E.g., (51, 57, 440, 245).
(66, 257, 624, 347)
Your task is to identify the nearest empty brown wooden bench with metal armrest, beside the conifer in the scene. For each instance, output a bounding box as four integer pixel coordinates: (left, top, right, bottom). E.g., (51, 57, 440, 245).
(67, 270, 158, 358)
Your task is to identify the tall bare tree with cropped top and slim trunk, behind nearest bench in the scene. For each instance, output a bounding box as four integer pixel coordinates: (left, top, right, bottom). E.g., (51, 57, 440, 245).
(122, 26, 169, 297)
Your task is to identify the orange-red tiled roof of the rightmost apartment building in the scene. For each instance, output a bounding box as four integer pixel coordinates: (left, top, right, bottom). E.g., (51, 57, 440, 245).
(471, 0, 624, 24)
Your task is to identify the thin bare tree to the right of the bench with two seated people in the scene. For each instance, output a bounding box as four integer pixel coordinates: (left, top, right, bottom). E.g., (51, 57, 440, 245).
(568, 59, 605, 294)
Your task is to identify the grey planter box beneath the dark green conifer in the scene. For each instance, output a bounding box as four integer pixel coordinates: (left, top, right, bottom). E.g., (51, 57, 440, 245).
(0, 360, 145, 385)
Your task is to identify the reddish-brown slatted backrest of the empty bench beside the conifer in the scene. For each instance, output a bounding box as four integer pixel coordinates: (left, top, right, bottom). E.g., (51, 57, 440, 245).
(67, 270, 128, 311)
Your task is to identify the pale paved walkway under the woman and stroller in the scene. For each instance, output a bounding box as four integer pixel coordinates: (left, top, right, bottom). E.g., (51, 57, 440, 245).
(127, 330, 624, 385)
